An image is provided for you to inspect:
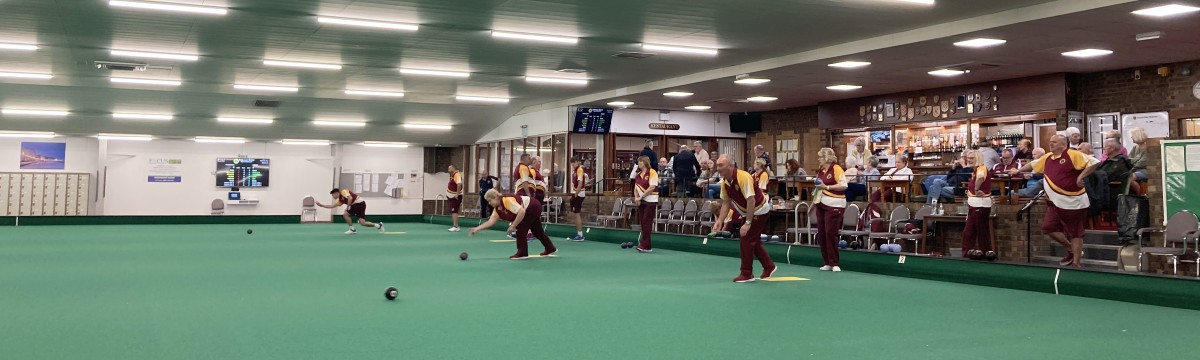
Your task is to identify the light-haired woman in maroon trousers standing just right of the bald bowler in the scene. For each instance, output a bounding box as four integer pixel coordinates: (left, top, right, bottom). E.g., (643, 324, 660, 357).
(816, 148, 850, 271)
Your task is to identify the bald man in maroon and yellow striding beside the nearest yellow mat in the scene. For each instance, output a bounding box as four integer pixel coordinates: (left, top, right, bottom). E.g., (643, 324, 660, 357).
(713, 155, 778, 282)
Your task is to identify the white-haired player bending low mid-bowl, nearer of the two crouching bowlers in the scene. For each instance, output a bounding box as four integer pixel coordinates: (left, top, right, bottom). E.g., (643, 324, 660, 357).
(470, 188, 558, 260)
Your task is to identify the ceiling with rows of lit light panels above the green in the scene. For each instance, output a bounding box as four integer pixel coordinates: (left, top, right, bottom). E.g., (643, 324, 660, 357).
(0, 0, 1200, 145)
